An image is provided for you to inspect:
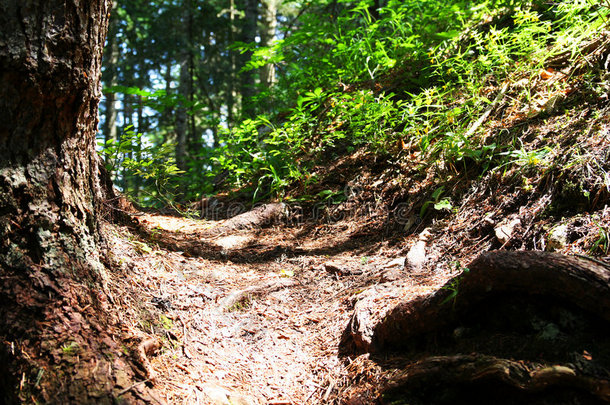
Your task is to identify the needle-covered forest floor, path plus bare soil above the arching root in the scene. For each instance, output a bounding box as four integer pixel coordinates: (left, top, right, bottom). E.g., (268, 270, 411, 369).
(104, 169, 610, 405)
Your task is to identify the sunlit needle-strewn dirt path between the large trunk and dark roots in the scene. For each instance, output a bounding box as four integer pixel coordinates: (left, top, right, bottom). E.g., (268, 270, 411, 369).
(105, 210, 446, 404)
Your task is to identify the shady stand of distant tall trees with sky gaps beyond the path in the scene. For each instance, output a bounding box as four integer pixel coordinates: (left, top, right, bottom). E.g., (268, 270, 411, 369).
(101, 0, 278, 204)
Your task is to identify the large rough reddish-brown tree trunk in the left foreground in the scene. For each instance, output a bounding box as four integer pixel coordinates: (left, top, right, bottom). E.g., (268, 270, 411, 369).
(0, 0, 153, 404)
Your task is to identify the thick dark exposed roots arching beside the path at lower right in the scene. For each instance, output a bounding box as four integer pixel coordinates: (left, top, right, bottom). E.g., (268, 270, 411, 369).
(342, 251, 610, 403)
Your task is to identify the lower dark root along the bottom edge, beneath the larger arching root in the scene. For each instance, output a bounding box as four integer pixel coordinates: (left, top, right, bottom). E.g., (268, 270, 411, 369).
(384, 355, 610, 404)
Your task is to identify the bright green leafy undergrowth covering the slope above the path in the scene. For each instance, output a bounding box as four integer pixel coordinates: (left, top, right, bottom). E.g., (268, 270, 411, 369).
(105, 0, 610, 207)
